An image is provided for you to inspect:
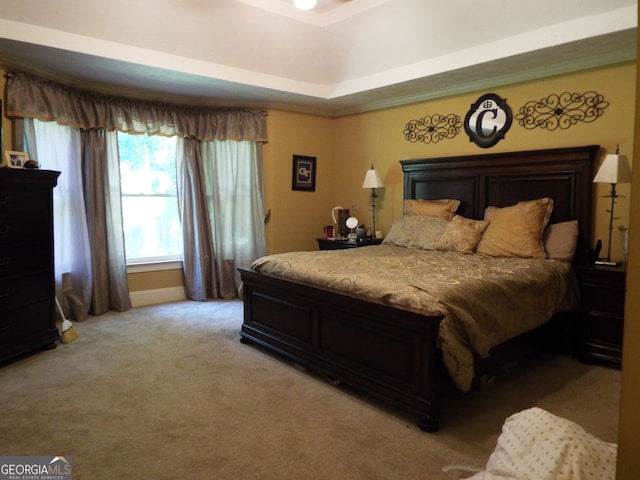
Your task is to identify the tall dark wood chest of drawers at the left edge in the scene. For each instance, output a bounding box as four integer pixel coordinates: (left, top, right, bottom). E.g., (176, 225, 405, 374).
(0, 168, 60, 362)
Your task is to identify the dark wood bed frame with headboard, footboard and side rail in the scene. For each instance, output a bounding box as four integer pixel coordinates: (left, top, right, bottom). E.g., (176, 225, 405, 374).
(240, 145, 599, 432)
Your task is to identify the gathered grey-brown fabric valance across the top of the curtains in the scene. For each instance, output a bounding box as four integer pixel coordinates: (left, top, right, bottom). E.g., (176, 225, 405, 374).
(5, 73, 267, 142)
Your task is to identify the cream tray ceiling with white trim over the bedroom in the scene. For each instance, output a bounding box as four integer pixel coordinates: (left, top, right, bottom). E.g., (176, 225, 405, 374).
(0, 0, 637, 117)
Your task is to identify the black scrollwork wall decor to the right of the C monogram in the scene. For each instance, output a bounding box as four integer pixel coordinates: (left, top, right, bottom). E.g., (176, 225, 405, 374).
(516, 91, 609, 131)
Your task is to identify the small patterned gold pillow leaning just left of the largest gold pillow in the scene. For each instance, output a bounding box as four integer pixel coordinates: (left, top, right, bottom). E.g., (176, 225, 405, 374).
(382, 215, 450, 250)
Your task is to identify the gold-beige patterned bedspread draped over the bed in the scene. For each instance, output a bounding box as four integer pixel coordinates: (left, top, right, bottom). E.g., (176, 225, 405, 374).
(252, 244, 578, 391)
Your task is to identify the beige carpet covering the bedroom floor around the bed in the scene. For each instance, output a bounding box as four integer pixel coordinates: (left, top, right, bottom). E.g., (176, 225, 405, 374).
(0, 301, 620, 480)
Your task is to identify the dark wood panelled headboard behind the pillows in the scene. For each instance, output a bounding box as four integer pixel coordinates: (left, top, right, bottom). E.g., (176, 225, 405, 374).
(400, 145, 600, 252)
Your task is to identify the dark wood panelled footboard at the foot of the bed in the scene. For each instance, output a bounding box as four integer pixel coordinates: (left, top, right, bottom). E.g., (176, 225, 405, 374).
(240, 269, 443, 432)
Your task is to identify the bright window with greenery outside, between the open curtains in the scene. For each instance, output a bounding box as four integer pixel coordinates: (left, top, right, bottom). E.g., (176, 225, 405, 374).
(118, 133, 182, 265)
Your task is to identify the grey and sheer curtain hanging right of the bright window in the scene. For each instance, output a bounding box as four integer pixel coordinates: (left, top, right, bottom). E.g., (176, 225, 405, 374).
(176, 138, 267, 301)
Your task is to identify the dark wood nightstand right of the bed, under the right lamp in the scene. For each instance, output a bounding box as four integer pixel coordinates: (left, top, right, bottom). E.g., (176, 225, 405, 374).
(575, 265, 627, 366)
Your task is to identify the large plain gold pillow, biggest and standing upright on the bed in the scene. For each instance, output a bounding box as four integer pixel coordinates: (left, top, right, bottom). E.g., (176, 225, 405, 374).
(476, 198, 553, 258)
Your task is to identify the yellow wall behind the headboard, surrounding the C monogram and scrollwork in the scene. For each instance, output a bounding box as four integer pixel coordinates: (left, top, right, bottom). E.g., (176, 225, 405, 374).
(332, 64, 635, 259)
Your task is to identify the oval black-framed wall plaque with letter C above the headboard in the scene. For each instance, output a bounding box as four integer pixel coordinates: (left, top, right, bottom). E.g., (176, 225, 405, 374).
(464, 93, 513, 148)
